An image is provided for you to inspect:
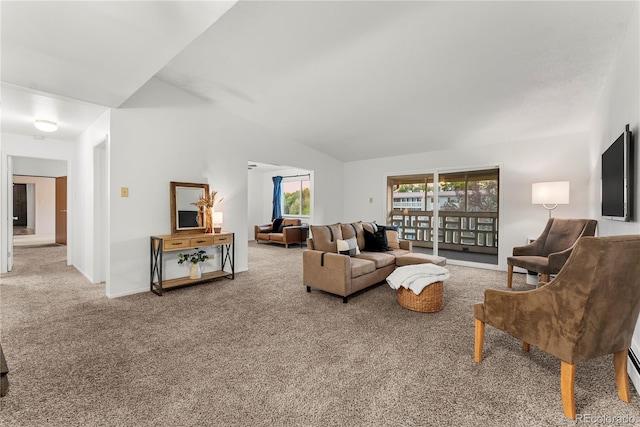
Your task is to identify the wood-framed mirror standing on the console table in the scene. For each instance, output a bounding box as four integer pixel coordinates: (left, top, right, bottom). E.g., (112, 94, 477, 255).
(169, 181, 209, 234)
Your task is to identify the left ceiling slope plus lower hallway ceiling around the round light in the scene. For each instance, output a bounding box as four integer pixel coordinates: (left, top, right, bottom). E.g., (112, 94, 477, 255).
(1, 0, 235, 140)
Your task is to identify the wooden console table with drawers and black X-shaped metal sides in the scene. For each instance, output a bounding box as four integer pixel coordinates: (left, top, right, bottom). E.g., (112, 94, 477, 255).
(150, 232, 235, 295)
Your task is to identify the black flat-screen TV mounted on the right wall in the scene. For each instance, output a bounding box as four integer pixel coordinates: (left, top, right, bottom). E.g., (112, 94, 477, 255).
(602, 125, 635, 221)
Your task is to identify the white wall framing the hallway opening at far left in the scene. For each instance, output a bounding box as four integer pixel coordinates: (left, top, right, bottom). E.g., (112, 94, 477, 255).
(0, 133, 76, 273)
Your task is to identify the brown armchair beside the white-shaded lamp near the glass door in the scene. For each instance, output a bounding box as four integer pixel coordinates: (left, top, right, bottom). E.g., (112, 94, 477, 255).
(507, 218, 598, 288)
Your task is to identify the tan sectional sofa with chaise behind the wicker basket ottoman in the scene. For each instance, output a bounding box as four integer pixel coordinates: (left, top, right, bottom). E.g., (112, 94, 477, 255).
(302, 222, 447, 303)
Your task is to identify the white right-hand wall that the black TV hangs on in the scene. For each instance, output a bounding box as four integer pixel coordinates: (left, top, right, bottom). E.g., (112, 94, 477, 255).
(589, 2, 640, 390)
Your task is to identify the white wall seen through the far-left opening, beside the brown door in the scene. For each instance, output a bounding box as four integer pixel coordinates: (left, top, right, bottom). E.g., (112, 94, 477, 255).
(13, 178, 55, 235)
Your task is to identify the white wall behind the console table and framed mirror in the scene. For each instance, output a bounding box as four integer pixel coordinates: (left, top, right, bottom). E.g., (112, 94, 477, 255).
(108, 79, 342, 296)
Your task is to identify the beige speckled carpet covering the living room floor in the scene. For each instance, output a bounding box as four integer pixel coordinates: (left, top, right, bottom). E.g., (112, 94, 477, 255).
(0, 243, 640, 427)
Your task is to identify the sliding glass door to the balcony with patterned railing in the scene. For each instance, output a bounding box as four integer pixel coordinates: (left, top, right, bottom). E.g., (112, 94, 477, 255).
(387, 169, 500, 264)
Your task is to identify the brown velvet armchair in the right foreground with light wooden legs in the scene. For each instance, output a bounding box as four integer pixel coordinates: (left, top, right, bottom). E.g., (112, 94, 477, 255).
(473, 236, 640, 419)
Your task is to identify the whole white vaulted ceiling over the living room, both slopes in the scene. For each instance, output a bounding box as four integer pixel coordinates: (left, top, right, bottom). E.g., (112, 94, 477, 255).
(2, 1, 638, 161)
